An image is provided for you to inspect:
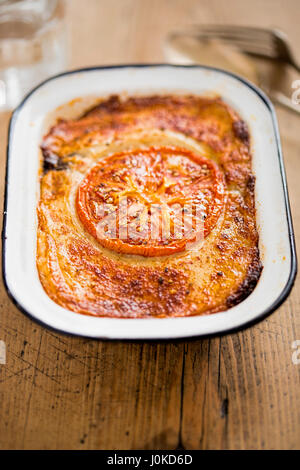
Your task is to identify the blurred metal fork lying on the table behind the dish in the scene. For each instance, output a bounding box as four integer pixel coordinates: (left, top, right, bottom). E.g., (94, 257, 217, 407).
(167, 25, 300, 113)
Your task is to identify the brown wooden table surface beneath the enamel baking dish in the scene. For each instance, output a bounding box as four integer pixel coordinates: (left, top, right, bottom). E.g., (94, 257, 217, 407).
(0, 0, 300, 449)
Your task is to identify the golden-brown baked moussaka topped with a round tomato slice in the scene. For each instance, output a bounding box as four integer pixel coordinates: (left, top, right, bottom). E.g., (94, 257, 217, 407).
(37, 95, 262, 318)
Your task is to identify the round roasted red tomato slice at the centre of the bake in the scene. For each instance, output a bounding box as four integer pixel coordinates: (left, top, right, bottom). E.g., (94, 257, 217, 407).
(76, 147, 224, 256)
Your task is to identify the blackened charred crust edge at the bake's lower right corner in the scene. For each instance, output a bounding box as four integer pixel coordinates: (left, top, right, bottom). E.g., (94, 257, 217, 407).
(226, 249, 263, 308)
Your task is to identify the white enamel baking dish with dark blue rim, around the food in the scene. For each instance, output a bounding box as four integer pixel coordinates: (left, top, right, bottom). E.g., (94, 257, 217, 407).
(3, 65, 297, 339)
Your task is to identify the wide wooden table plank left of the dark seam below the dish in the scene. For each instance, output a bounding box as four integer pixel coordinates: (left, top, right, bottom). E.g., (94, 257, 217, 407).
(0, 320, 183, 449)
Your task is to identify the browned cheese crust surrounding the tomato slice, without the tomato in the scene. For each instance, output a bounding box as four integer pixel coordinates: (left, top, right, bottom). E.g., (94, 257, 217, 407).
(37, 95, 262, 318)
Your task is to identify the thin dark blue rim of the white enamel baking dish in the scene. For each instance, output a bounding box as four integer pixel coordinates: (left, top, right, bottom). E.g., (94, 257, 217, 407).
(2, 63, 297, 342)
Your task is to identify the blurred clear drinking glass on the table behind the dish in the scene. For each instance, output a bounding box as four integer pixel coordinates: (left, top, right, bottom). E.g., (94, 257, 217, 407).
(0, 0, 67, 111)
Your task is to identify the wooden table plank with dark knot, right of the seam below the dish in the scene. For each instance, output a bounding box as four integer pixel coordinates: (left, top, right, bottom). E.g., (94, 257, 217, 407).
(181, 86, 300, 449)
